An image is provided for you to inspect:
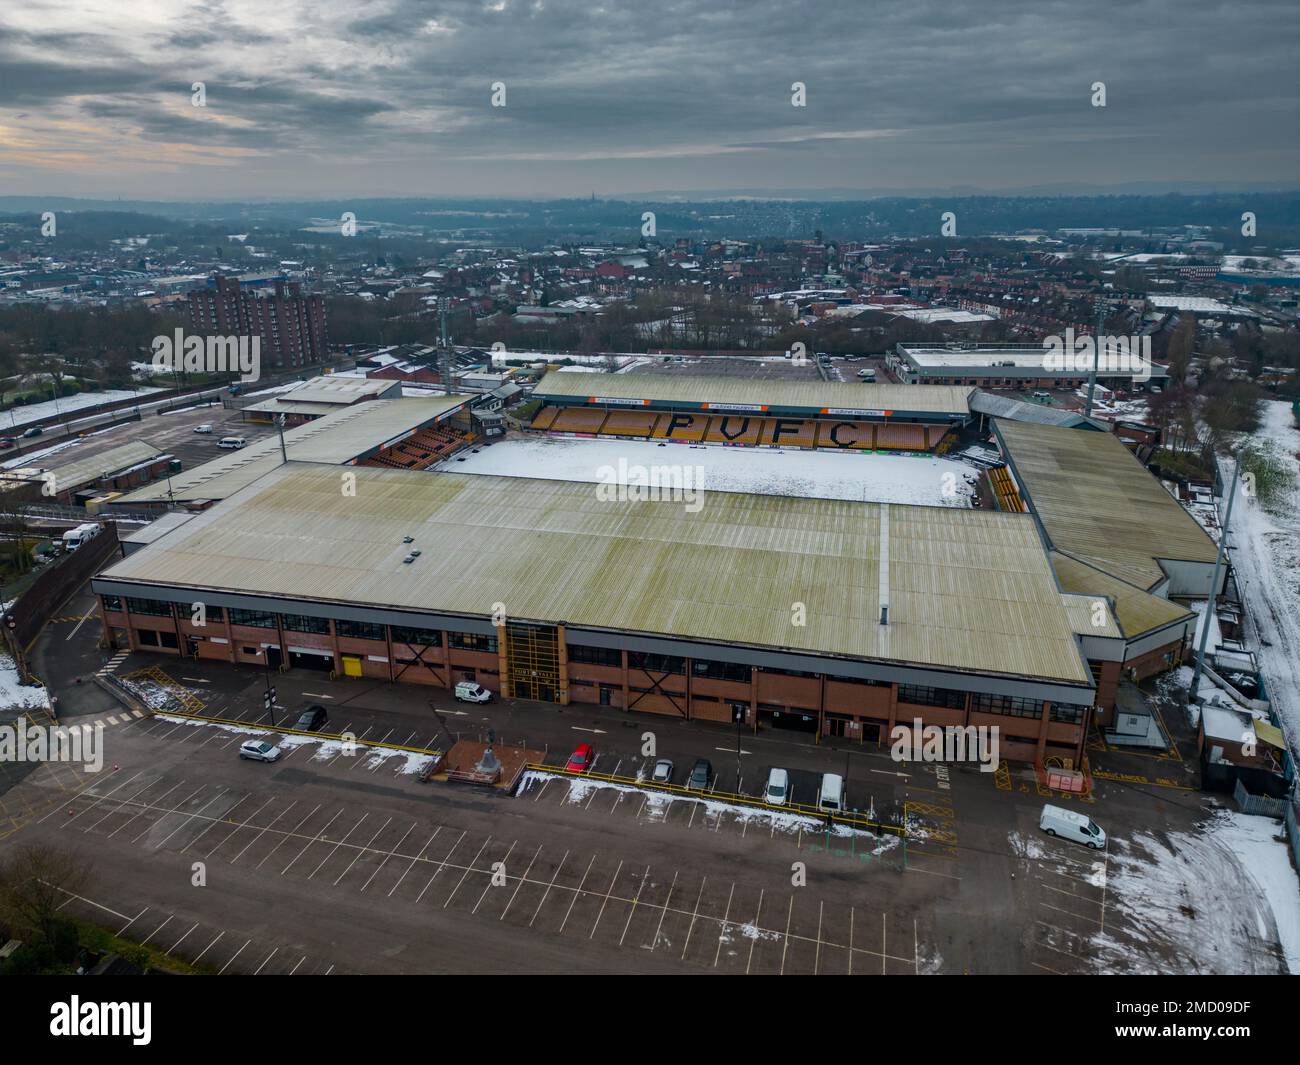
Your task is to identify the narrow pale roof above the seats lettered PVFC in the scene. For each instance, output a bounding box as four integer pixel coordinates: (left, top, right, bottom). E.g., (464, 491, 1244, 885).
(533, 371, 974, 415)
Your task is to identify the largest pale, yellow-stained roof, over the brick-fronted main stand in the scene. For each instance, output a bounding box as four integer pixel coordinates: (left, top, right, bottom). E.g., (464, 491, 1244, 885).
(100, 463, 1092, 687)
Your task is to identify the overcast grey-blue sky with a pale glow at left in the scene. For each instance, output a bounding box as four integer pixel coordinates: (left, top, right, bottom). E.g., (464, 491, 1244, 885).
(0, 0, 1300, 199)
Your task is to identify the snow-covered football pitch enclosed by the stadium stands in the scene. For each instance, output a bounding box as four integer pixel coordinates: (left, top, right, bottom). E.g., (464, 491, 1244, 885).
(438, 437, 976, 507)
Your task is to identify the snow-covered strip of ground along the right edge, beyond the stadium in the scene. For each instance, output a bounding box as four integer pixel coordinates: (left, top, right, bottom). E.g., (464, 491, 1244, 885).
(1225, 401, 1300, 752)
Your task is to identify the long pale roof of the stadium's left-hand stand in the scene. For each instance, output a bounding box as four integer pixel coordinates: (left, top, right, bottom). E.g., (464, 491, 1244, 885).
(114, 395, 469, 506)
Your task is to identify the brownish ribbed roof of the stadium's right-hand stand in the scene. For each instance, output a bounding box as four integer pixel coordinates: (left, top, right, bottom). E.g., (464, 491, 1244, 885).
(995, 420, 1216, 590)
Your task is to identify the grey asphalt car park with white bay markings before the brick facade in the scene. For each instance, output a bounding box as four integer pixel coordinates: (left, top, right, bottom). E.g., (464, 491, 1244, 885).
(10, 622, 1273, 975)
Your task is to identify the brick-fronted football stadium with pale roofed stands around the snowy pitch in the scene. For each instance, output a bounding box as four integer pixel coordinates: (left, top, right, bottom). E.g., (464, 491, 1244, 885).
(83, 373, 1214, 765)
